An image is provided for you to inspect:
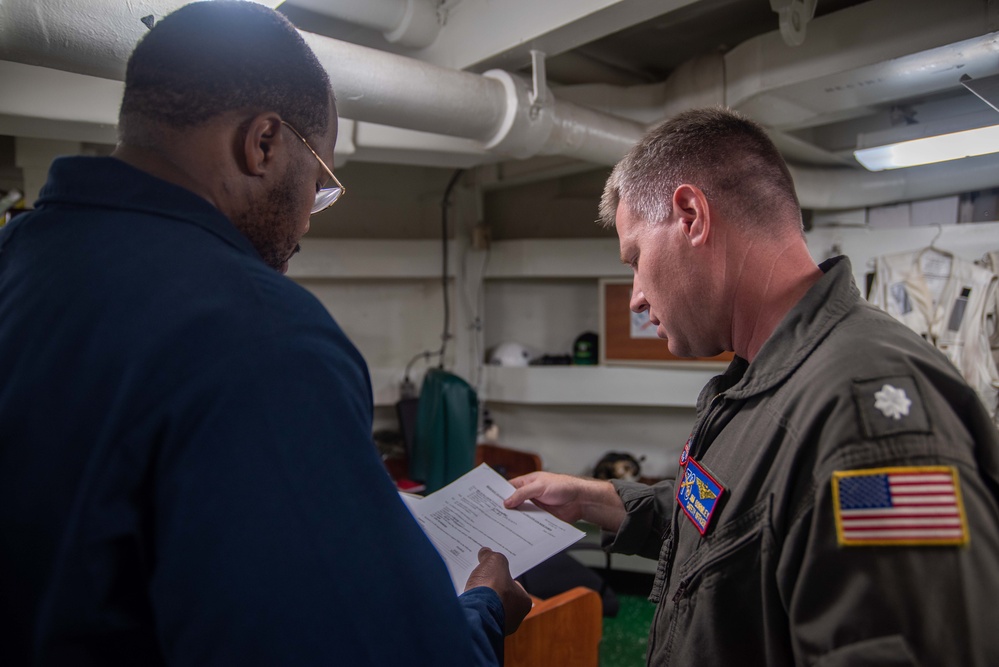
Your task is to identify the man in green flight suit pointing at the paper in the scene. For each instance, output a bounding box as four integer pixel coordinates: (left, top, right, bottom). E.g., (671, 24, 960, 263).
(507, 109, 999, 666)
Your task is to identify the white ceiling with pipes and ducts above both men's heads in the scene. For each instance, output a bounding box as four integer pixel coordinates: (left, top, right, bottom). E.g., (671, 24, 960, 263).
(0, 0, 999, 209)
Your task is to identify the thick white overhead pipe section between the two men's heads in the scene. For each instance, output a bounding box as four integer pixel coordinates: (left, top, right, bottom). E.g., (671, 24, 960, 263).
(302, 33, 645, 164)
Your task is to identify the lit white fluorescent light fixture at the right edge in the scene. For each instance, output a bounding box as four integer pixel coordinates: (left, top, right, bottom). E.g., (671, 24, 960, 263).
(853, 125, 999, 171)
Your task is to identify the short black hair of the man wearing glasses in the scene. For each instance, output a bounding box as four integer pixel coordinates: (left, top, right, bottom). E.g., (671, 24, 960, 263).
(119, 0, 332, 139)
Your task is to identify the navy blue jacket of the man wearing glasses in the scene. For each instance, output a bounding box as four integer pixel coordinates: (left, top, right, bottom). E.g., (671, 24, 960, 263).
(0, 157, 503, 667)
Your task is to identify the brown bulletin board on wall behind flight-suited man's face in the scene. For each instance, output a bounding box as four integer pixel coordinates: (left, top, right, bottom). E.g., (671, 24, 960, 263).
(600, 278, 733, 368)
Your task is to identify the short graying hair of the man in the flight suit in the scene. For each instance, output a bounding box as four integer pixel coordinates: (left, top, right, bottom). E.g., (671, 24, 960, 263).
(600, 107, 801, 230)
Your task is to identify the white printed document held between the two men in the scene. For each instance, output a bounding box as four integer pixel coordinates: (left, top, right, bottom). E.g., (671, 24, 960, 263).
(403, 463, 585, 593)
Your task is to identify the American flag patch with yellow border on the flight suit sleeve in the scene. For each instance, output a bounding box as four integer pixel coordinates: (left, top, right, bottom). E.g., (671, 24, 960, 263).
(832, 466, 968, 546)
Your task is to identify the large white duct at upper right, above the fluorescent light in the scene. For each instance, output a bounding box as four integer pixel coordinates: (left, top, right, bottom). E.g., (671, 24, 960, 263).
(558, 0, 999, 130)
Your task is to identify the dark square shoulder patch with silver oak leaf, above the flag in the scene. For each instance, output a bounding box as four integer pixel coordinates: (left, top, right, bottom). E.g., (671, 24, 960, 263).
(853, 375, 930, 438)
